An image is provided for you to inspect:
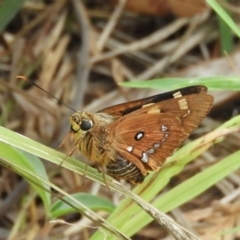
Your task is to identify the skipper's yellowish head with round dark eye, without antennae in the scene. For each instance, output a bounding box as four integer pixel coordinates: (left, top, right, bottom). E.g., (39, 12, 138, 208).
(70, 112, 93, 135)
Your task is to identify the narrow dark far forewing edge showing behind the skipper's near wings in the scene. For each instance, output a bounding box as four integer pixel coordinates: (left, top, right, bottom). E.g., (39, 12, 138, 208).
(99, 85, 207, 116)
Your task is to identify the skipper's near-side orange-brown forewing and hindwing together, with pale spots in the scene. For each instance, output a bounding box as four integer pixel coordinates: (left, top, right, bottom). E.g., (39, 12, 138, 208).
(104, 92, 213, 175)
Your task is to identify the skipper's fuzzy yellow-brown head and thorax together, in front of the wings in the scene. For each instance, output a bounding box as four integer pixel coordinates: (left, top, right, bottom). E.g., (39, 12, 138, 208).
(70, 111, 116, 164)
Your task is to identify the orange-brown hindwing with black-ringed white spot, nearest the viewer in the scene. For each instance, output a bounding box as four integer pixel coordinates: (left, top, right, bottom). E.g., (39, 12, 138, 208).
(107, 113, 184, 175)
